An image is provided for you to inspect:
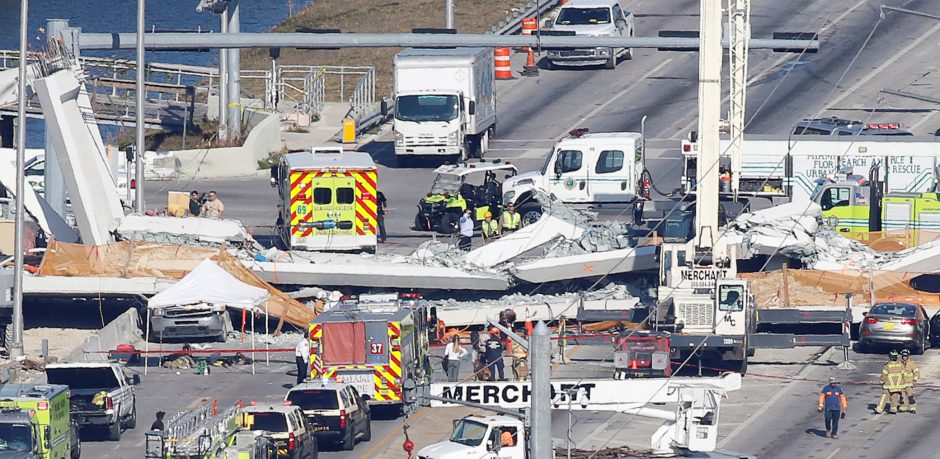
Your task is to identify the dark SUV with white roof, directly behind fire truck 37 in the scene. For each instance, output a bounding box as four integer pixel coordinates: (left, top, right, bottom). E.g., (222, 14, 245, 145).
(286, 382, 372, 451)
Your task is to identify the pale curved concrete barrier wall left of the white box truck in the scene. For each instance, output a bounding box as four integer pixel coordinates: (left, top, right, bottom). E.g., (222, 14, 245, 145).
(171, 109, 283, 180)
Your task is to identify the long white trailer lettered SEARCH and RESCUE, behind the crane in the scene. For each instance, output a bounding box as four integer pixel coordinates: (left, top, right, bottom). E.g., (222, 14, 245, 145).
(681, 136, 940, 203)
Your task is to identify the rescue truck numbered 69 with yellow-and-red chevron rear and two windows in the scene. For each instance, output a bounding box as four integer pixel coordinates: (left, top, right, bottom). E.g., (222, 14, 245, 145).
(271, 147, 378, 252)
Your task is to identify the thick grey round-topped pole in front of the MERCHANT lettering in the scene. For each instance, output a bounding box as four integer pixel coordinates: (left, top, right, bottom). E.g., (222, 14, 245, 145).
(529, 321, 555, 458)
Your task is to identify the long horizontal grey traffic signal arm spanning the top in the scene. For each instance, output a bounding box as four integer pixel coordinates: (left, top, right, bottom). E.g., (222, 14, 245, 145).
(79, 33, 819, 51)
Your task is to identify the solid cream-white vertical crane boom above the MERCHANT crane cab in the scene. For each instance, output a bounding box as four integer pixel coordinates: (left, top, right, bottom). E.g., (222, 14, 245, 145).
(695, 0, 724, 255)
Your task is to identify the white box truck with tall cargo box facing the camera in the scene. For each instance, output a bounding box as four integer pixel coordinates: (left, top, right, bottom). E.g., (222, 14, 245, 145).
(382, 48, 496, 165)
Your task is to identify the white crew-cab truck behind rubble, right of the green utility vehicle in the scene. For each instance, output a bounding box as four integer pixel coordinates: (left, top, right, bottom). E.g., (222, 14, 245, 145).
(503, 129, 648, 224)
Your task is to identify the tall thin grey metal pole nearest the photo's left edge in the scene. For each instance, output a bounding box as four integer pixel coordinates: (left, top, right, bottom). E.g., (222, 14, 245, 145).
(6, 0, 29, 358)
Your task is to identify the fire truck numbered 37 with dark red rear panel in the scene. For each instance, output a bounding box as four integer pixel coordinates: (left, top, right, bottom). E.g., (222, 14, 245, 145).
(309, 293, 431, 414)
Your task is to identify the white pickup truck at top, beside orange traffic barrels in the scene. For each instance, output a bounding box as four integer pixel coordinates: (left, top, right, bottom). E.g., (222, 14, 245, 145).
(545, 0, 634, 69)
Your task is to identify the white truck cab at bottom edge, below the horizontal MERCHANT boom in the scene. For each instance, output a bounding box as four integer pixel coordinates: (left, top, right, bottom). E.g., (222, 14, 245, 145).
(418, 416, 527, 459)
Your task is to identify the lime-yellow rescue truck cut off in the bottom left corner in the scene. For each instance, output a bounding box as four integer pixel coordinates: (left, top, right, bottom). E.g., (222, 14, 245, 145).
(0, 384, 81, 459)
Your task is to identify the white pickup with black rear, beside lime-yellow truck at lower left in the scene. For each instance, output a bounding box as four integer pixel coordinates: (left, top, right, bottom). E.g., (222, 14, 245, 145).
(46, 362, 140, 441)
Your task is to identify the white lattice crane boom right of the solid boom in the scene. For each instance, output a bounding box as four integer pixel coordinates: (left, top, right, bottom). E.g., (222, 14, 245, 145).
(728, 0, 751, 201)
